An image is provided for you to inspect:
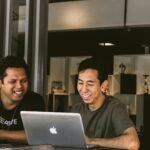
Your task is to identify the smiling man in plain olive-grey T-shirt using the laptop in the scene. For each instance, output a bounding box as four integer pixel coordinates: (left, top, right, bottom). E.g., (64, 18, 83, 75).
(73, 58, 139, 150)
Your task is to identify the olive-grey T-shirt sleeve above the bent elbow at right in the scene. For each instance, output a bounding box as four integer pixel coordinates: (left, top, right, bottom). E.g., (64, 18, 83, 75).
(112, 103, 134, 135)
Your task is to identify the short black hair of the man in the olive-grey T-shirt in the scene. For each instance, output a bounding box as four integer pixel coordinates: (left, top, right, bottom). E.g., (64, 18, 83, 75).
(78, 57, 108, 83)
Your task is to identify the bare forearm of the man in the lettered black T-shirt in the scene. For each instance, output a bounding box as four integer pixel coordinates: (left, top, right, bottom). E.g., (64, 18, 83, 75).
(0, 130, 27, 143)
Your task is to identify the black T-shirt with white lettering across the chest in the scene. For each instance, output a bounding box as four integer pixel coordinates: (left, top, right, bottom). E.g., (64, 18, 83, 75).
(0, 91, 45, 131)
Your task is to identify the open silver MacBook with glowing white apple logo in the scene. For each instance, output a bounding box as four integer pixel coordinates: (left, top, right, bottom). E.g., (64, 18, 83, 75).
(21, 111, 103, 148)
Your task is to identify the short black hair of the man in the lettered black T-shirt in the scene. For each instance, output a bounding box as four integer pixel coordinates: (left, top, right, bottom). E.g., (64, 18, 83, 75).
(0, 56, 29, 80)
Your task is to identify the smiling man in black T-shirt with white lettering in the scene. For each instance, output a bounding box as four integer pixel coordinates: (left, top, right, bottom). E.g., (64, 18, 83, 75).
(0, 56, 45, 143)
